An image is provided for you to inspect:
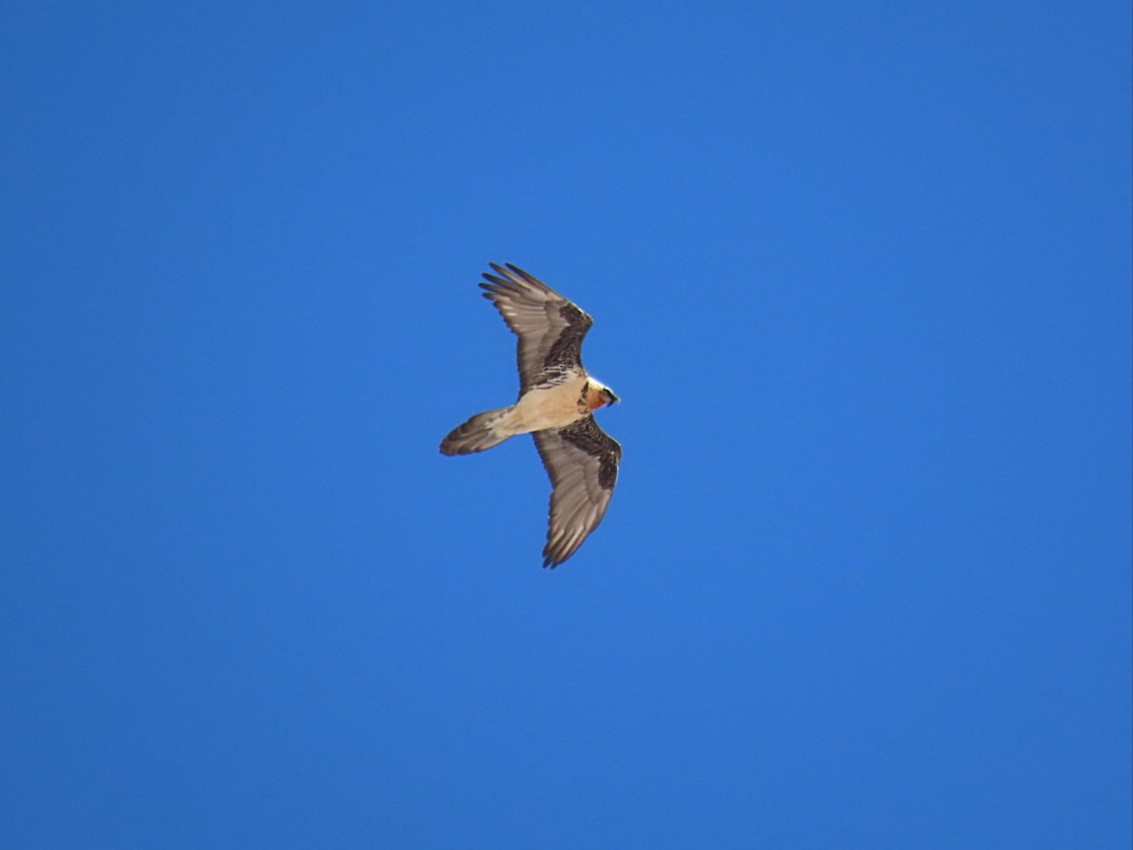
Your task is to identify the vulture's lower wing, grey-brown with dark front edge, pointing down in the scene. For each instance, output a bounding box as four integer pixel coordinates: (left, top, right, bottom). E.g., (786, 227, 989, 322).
(533, 416, 622, 567)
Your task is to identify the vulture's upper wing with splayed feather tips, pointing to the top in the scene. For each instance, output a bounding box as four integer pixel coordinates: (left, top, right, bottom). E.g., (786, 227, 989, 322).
(480, 263, 594, 394)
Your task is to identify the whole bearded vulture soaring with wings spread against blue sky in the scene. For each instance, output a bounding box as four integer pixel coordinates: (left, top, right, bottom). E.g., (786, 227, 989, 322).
(441, 263, 622, 568)
